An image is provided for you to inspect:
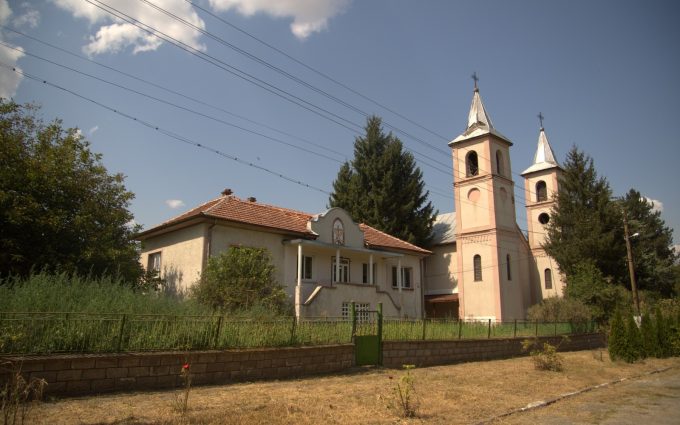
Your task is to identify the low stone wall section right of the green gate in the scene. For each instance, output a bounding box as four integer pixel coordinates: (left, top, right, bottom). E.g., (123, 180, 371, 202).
(383, 333, 606, 368)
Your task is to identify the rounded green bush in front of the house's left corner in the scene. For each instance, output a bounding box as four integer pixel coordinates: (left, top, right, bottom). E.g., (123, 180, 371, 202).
(192, 247, 289, 313)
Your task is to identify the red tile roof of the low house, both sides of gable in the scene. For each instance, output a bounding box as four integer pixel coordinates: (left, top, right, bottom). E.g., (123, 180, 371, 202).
(137, 195, 430, 254)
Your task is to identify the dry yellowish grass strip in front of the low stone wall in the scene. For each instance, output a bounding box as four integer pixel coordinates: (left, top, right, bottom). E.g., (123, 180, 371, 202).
(27, 351, 680, 425)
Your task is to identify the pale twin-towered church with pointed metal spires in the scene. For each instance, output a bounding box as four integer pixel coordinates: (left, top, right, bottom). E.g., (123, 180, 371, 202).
(423, 77, 565, 321)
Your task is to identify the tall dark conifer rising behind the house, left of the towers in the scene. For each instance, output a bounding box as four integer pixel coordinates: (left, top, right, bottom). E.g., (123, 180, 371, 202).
(329, 116, 436, 246)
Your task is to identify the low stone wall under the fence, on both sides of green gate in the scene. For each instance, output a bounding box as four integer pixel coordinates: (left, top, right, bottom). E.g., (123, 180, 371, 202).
(0, 334, 605, 396)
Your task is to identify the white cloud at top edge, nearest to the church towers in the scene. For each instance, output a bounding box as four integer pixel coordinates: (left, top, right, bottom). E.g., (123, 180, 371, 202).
(210, 0, 351, 39)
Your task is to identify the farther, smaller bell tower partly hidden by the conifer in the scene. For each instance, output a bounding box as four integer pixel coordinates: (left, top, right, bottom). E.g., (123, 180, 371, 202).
(522, 113, 565, 296)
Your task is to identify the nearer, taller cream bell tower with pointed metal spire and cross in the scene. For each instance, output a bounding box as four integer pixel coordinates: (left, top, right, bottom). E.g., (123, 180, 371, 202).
(449, 74, 524, 320)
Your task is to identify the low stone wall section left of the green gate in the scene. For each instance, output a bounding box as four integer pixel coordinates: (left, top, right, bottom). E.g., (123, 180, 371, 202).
(0, 344, 354, 396)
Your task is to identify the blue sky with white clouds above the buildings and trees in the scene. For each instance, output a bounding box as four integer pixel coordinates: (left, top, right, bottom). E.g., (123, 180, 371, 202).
(0, 0, 680, 248)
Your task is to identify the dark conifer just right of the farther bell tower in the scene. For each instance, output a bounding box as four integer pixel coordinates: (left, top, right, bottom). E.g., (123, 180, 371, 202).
(544, 147, 627, 282)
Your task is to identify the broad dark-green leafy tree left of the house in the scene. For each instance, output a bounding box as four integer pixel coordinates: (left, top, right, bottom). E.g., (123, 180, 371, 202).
(0, 100, 141, 281)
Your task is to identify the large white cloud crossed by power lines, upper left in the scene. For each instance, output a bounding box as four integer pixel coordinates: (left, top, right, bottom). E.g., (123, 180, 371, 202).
(53, 0, 205, 56)
